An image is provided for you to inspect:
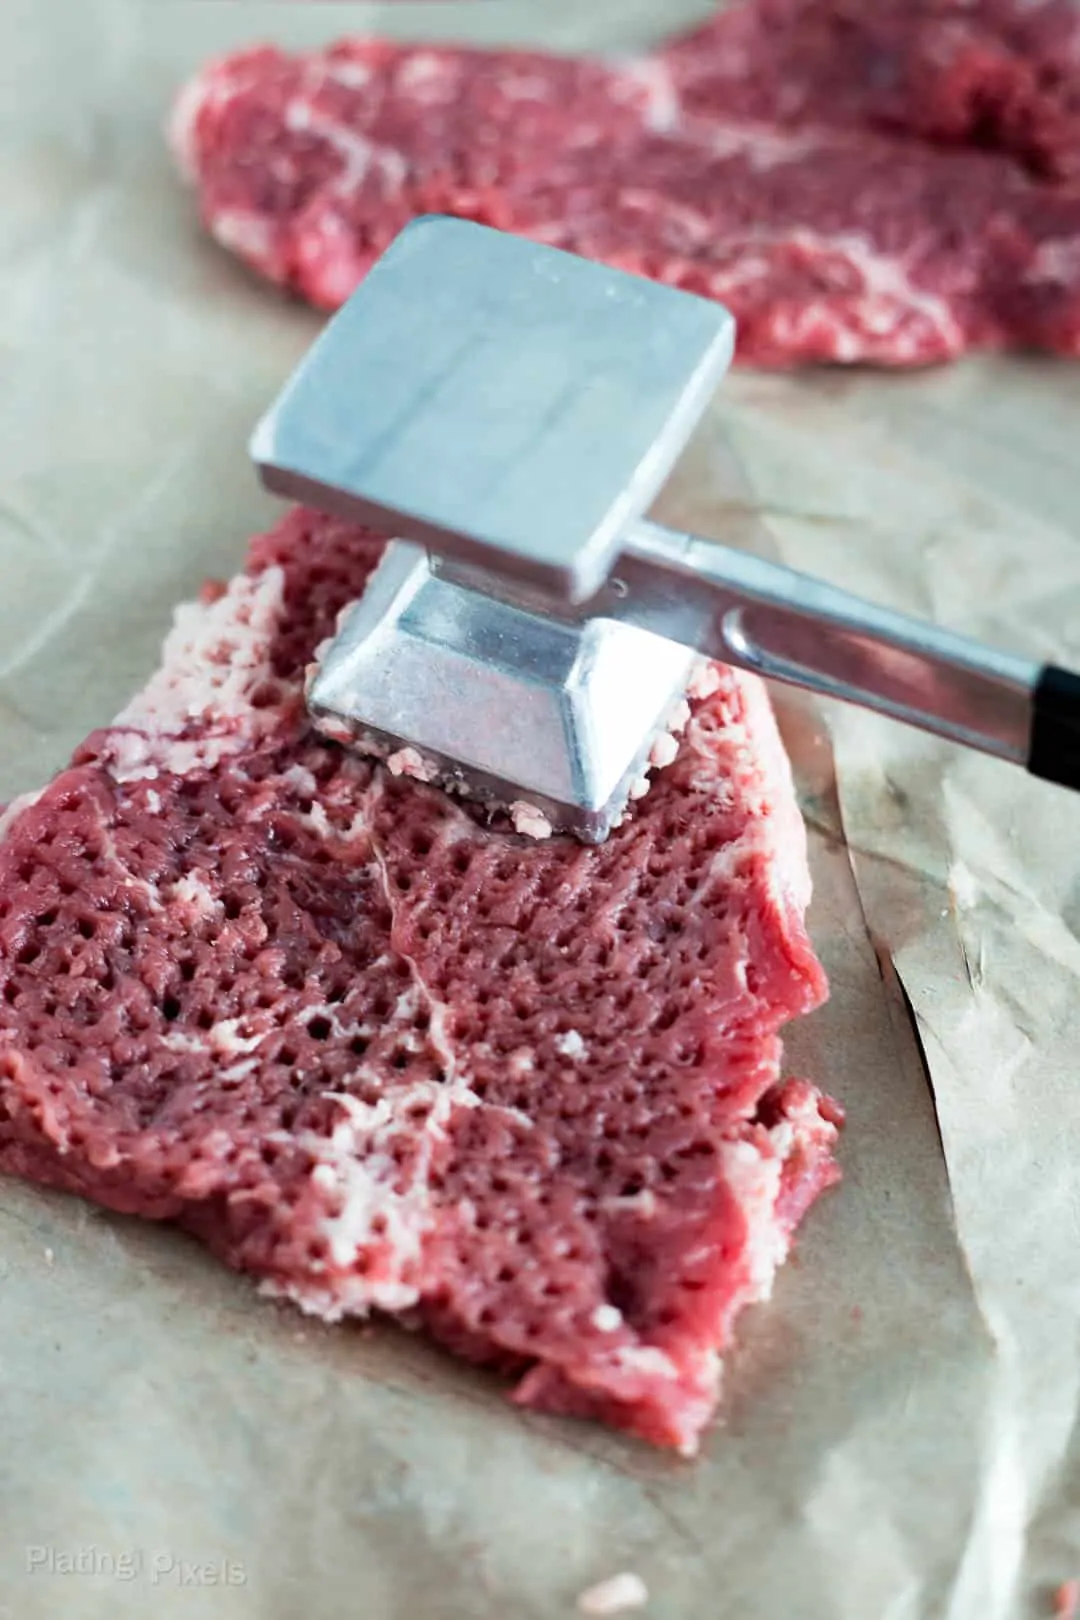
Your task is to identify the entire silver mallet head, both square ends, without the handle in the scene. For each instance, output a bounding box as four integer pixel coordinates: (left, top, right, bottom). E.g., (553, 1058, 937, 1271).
(251, 217, 735, 841)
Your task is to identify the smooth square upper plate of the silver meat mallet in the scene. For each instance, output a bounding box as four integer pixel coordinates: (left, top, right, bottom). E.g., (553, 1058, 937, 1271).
(251, 208, 735, 603)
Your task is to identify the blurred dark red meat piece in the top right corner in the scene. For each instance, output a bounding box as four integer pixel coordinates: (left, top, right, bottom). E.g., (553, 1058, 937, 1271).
(665, 0, 1080, 180)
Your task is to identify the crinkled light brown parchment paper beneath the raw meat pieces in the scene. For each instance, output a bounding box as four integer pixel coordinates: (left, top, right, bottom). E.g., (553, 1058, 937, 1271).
(0, 0, 1080, 1620)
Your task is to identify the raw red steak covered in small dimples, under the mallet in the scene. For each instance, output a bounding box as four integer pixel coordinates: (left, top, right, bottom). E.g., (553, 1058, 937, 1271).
(0, 510, 839, 1452)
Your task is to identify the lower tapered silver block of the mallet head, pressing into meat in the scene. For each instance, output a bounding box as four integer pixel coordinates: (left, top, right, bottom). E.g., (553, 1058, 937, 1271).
(308, 541, 696, 842)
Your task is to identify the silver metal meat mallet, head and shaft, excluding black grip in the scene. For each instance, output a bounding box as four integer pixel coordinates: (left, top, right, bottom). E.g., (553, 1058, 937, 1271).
(253, 219, 1041, 839)
